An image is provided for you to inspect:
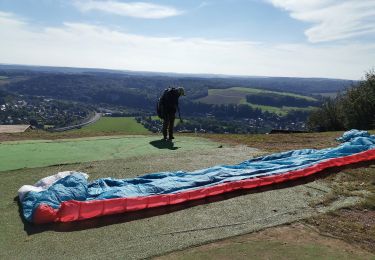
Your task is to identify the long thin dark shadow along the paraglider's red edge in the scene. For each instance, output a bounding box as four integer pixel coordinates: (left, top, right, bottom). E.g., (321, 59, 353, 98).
(19, 161, 374, 235)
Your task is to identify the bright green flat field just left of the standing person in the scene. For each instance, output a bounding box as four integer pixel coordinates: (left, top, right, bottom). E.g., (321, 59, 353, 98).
(72, 117, 150, 134)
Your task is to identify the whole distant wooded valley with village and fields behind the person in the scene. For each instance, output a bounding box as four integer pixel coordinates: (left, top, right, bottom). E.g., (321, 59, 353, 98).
(0, 65, 353, 133)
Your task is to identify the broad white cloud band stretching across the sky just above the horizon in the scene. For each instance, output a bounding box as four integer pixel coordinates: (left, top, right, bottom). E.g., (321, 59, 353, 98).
(0, 13, 375, 79)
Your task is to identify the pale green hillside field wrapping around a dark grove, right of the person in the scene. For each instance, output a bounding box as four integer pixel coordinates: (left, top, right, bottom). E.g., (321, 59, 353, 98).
(196, 87, 316, 114)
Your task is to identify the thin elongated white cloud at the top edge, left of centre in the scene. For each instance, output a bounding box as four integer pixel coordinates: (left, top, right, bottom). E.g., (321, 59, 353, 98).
(73, 0, 183, 19)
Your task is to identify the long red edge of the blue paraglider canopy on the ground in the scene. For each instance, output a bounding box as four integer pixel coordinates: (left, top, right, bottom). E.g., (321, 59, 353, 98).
(33, 149, 375, 224)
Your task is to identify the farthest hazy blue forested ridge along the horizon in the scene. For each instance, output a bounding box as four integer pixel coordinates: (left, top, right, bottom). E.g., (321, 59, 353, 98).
(0, 64, 355, 98)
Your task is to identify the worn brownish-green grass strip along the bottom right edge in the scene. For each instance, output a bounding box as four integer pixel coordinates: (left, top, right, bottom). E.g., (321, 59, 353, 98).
(157, 234, 372, 260)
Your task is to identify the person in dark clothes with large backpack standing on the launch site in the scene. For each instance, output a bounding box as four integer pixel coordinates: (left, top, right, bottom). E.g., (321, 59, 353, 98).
(157, 87, 185, 141)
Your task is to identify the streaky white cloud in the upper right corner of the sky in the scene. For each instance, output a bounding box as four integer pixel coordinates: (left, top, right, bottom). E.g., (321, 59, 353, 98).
(266, 0, 375, 42)
